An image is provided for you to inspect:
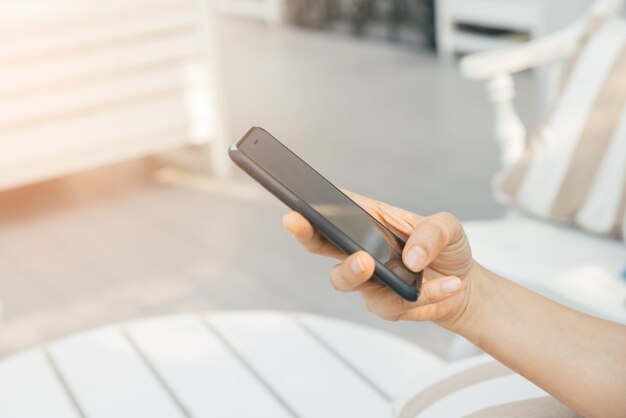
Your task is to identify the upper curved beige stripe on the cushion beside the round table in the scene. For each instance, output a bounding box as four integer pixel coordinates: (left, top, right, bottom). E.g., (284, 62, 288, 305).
(399, 361, 513, 418)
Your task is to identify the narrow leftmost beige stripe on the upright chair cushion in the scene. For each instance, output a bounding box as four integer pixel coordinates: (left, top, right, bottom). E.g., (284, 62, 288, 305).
(499, 17, 605, 199)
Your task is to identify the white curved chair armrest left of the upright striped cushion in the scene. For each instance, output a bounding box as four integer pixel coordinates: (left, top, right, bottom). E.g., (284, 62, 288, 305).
(460, 19, 586, 80)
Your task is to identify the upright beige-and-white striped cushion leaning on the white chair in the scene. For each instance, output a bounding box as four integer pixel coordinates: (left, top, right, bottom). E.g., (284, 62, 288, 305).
(496, 19, 626, 236)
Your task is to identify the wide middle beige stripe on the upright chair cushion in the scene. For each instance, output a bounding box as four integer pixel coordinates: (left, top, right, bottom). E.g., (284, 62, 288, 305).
(552, 48, 626, 218)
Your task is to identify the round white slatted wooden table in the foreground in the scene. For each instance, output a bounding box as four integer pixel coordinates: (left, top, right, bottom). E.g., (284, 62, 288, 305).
(0, 311, 444, 418)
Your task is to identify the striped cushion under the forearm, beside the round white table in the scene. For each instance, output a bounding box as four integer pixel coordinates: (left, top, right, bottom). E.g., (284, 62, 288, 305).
(398, 355, 579, 418)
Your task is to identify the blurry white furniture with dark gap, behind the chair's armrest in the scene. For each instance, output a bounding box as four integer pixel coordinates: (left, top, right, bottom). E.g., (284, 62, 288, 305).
(436, 0, 591, 57)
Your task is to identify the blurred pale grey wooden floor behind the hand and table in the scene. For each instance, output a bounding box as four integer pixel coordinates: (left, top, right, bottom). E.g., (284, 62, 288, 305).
(0, 19, 534, 355)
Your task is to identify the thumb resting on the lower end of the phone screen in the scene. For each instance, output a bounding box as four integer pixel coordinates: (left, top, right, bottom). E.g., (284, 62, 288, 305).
(402, 212, 463, 271)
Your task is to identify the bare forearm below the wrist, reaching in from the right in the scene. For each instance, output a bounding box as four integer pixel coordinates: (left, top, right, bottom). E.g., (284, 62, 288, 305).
(450, 266, 626, 417)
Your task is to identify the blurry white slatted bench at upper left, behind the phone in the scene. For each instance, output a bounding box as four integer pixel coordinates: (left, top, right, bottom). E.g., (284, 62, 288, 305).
(0, 0, 228, 189)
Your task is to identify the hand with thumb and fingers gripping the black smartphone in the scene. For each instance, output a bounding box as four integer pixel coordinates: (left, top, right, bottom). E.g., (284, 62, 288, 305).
(283, 190, 479, 328)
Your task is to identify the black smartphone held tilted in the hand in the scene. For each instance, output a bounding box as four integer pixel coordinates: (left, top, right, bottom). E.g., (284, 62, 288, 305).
(229, 127, 422, 301)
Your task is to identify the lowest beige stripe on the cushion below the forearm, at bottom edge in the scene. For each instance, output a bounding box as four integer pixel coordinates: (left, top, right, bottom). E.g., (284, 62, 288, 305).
(465, 397, 581, 418)
